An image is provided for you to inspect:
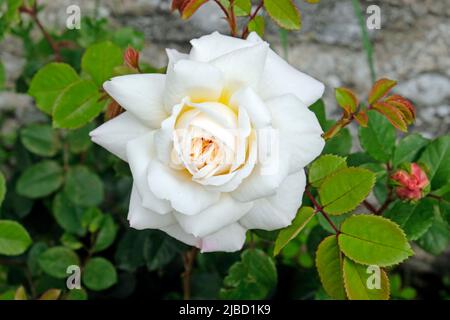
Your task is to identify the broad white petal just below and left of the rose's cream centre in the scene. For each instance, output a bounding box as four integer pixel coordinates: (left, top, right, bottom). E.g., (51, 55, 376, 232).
(147, 160, 220, 215)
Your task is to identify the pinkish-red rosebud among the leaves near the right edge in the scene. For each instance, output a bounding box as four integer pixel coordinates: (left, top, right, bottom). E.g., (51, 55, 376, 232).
(391, 163, 430, 200)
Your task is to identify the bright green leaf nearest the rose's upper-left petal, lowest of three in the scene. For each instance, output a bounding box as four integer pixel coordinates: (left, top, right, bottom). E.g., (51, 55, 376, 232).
(53, 80, 105, 129)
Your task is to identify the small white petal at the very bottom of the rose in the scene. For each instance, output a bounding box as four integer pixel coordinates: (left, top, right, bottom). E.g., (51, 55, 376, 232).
(200, 223, 247, 252)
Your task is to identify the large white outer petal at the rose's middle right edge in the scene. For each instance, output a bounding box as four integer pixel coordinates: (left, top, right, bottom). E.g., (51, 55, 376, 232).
(266, 94, 325, 173)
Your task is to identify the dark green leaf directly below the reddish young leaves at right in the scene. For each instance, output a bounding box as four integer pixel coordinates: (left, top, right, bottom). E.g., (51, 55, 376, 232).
(359, 110, 396, 162)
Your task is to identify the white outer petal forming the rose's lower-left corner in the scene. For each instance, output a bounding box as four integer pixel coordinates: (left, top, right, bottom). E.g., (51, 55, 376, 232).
(128, 185, 176, 230)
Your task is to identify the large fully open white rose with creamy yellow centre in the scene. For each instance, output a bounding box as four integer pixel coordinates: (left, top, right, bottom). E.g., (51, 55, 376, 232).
(91, 32, 324, 252)
